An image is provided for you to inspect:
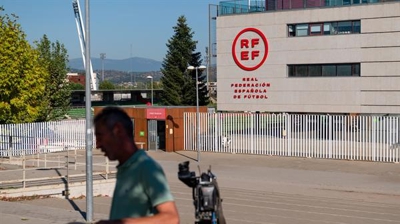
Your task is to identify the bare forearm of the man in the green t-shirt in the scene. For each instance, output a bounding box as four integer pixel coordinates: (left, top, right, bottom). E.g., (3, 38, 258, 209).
(96, 201, 179, 224)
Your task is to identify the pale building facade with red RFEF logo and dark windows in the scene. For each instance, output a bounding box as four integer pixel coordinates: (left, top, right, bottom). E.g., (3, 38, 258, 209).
(216, 0, 400, 114)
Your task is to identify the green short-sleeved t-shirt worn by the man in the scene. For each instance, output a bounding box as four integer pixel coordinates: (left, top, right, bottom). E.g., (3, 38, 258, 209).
(110, 150, 174, 220)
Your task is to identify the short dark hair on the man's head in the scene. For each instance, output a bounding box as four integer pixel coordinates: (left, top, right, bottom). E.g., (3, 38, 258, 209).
(93, 107, 133, 138)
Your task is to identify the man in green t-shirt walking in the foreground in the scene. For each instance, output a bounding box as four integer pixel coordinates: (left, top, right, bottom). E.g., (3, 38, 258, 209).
(94, 107, 179, 224)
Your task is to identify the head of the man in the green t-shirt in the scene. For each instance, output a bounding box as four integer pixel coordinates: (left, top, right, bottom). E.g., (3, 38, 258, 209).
(94, 107, 134, 162)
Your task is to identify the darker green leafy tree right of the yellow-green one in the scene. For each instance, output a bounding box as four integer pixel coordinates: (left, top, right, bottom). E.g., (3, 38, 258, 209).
(35, 35, 71, 121)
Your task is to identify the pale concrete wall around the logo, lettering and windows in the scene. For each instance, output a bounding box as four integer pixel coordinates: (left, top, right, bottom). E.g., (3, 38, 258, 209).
(217, 2, 400, 114)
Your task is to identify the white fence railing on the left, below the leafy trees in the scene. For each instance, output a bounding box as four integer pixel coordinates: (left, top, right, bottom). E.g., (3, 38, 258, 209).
(0, 120, 86, 157)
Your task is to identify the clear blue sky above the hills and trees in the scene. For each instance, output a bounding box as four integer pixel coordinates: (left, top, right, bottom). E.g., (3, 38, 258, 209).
(0, 0, 220, 61)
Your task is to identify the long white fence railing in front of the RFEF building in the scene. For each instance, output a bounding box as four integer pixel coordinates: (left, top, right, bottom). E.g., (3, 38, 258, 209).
(184, 113, 400, 162)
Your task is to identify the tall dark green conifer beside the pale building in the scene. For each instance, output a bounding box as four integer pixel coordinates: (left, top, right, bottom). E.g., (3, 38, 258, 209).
(160, 16, 208, 106)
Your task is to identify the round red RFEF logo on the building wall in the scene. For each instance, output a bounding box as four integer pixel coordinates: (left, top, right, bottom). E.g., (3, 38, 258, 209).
(232, 28, 268, 71)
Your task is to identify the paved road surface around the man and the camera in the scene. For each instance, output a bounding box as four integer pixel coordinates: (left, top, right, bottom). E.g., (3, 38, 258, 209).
(0, 152, 400, 224)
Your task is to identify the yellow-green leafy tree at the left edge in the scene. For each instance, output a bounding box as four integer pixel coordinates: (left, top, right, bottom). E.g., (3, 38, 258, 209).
(0, 7, 47, 124)
